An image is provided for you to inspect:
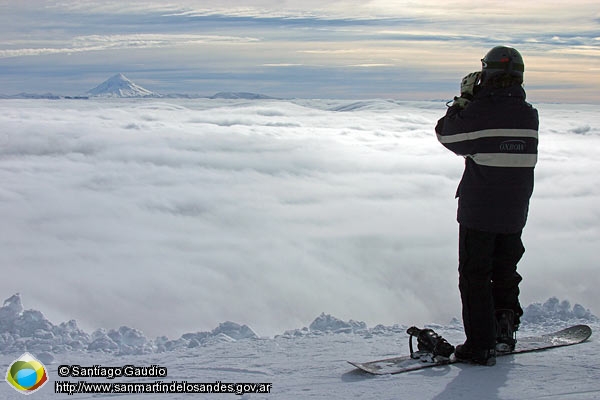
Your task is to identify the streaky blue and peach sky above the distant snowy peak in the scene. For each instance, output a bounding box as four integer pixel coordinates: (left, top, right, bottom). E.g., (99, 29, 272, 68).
(0, 0, 600, 103)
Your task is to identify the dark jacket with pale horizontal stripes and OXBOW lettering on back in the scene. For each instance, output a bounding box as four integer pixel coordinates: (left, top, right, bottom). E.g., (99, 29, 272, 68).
(435, 85, 539, 233)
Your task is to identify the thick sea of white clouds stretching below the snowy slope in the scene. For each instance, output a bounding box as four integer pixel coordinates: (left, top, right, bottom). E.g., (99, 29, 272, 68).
(0, 99, 600, 338)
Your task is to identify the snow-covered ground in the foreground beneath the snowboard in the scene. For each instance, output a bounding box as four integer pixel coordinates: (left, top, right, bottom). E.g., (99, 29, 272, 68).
(0, 296, 600, 400)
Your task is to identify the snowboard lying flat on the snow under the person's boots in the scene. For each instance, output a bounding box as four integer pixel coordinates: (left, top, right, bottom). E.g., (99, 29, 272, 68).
(348, 325, 592, 375)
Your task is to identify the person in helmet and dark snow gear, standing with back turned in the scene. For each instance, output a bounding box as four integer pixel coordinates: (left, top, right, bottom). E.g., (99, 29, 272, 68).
(435, 46, 539, 365)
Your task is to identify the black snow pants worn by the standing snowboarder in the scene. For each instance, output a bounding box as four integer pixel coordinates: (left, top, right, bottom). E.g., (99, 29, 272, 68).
(458, 225, 525, 350)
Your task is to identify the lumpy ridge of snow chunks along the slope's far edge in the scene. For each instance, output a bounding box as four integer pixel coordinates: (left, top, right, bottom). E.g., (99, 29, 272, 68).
(0, 293, 598, 354)
